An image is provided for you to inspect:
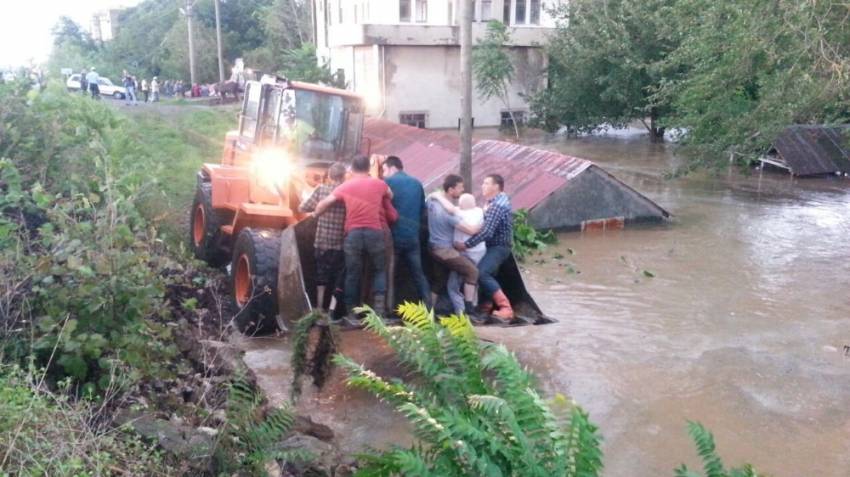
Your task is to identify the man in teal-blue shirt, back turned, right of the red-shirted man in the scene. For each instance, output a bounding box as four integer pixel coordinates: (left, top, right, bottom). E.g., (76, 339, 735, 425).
(382, 156, 431, 306)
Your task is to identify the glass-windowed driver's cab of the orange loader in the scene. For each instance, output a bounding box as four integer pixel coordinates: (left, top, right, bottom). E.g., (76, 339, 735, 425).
(239, 77, 364, 167)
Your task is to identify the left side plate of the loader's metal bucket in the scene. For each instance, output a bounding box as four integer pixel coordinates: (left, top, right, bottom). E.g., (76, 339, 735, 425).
(277, 220, 316, 331)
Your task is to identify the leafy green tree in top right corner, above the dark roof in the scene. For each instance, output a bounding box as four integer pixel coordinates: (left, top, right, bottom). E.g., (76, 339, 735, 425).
(656, 0, 850, 164)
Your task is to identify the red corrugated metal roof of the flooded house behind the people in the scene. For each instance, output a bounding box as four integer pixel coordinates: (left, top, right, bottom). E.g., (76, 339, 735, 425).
(363, 118, 669, 228)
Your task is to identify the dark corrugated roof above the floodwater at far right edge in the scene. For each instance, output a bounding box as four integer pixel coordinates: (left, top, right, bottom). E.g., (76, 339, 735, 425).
(773, 125, 850, 176)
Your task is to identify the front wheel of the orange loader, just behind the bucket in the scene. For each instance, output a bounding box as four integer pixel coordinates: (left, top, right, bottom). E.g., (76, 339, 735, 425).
(230, 228, 280, 335)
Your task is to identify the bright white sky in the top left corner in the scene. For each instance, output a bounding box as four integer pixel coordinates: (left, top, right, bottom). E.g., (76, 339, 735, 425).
(0, 0, 140, 68)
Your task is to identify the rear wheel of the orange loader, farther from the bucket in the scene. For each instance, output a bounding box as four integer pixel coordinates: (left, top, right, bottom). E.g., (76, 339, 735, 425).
(189, 181, 228, 267)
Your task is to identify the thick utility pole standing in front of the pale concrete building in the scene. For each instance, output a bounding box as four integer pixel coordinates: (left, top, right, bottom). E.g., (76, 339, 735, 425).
(460, 0, 474, 190)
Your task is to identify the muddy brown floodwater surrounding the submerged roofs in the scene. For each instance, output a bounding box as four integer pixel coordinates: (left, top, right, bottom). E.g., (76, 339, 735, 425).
(238, 130, 850, 477)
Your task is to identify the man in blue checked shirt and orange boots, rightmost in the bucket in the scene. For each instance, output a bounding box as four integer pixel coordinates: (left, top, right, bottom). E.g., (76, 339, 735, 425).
(455, 174, 514, 321)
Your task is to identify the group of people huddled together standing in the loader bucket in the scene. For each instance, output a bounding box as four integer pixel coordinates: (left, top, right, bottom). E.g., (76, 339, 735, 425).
(300, 155, 515, 327)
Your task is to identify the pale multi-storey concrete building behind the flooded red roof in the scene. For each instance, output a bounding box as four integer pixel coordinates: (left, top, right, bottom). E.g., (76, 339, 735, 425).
(314, 0, 563, 128)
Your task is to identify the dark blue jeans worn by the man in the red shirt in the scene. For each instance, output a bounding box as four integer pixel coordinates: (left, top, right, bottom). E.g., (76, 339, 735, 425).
(342, 228, 387, 310)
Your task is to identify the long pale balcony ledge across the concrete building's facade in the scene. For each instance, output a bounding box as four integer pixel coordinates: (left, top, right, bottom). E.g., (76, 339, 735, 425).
(328, 23, 554, 48)
